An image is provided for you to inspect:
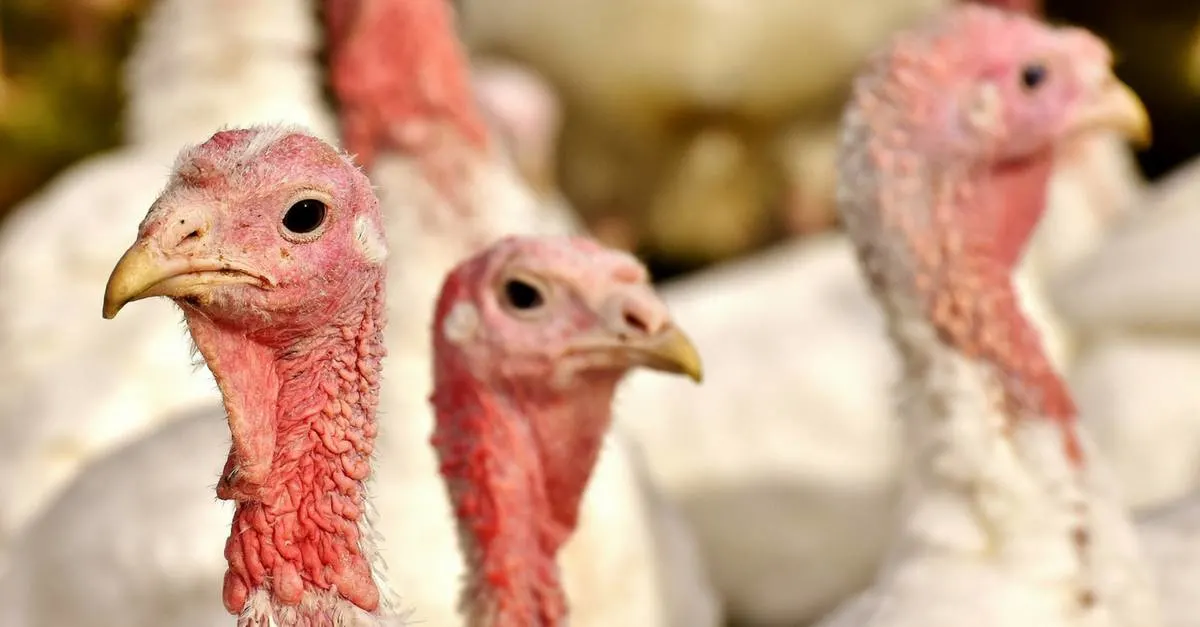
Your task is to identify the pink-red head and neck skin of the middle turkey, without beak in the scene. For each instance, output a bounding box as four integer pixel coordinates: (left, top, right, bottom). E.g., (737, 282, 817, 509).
(431, 238, 670, 627)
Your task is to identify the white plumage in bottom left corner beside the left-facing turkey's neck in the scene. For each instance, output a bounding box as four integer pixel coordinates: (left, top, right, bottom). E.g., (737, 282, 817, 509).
(0, 405, 234, 627)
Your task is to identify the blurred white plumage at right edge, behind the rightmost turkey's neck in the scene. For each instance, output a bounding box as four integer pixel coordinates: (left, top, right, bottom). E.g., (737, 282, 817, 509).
(1052, 154, 1200, 507)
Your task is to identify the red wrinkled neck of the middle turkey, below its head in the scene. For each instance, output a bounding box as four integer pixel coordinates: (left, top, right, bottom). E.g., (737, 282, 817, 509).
(432, 368, 616, 627)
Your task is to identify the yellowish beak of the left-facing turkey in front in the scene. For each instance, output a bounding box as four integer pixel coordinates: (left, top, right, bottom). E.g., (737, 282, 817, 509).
(104, 239, 271, 320)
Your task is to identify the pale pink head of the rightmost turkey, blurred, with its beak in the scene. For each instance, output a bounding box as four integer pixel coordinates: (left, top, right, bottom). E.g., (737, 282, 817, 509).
(839, 4, 1148, 276)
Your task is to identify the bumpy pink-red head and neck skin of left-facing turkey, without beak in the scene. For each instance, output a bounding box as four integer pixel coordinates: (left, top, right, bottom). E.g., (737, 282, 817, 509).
(129, 129, 384, 625)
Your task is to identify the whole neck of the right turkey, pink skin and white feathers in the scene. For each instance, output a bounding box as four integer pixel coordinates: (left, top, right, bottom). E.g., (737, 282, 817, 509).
(850, 141, 1088, 557)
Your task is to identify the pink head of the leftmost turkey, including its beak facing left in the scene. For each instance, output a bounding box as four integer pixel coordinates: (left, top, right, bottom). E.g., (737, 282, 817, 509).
(104, 126, 386, 335)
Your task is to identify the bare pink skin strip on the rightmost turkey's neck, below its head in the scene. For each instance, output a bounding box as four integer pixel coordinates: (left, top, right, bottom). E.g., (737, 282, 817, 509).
(890, 154, 1084, 449)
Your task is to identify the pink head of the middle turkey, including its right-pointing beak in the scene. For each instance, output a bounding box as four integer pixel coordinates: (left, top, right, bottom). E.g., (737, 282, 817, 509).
(434, 237, 701, 386)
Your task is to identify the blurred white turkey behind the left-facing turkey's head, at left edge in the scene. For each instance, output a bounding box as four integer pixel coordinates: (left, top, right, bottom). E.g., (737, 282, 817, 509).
(0, 0, 335, 551)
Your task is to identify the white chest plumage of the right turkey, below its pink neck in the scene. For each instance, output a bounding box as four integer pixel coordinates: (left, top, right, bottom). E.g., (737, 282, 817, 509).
(820, 329, 1160, 627)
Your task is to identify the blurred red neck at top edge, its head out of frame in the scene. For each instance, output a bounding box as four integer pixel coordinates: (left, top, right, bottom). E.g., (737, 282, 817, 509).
(325, 0, 487, 168)
